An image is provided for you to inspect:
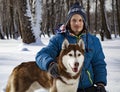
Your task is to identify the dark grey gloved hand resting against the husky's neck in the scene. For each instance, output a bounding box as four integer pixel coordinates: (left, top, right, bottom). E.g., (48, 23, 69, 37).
(48, 62, 59, 78)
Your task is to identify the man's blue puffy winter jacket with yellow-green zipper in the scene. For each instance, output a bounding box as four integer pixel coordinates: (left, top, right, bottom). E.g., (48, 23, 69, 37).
(36, 32, 107, 89)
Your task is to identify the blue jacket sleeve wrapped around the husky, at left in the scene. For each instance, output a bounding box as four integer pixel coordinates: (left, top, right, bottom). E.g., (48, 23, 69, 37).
(35, 36, 60, 71)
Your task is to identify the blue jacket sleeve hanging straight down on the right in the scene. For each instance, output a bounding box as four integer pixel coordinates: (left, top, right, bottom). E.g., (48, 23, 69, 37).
(92, 38, 107, 85)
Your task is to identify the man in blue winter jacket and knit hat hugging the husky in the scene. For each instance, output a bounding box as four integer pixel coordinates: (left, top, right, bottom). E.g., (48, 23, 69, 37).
(36, 2, 107, 92)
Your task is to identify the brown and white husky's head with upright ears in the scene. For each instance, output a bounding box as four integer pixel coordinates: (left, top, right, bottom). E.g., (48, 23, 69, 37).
(59, 39, 85, 76)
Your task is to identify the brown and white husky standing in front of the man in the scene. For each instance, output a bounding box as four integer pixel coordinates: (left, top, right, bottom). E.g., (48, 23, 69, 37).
(6, 39, 84, 92)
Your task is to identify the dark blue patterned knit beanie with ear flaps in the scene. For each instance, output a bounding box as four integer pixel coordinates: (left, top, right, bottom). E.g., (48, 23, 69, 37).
(66, 2, 87, 27)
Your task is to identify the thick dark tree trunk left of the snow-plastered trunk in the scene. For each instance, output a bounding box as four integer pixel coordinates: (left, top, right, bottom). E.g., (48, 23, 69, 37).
(17, 0, 35, 44)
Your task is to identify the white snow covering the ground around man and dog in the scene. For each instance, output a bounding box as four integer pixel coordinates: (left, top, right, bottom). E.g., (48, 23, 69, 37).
(0, 37, 120, 92)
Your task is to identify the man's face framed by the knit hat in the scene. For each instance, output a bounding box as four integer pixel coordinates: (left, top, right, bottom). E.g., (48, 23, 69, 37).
(70, 14, 84, 35)
